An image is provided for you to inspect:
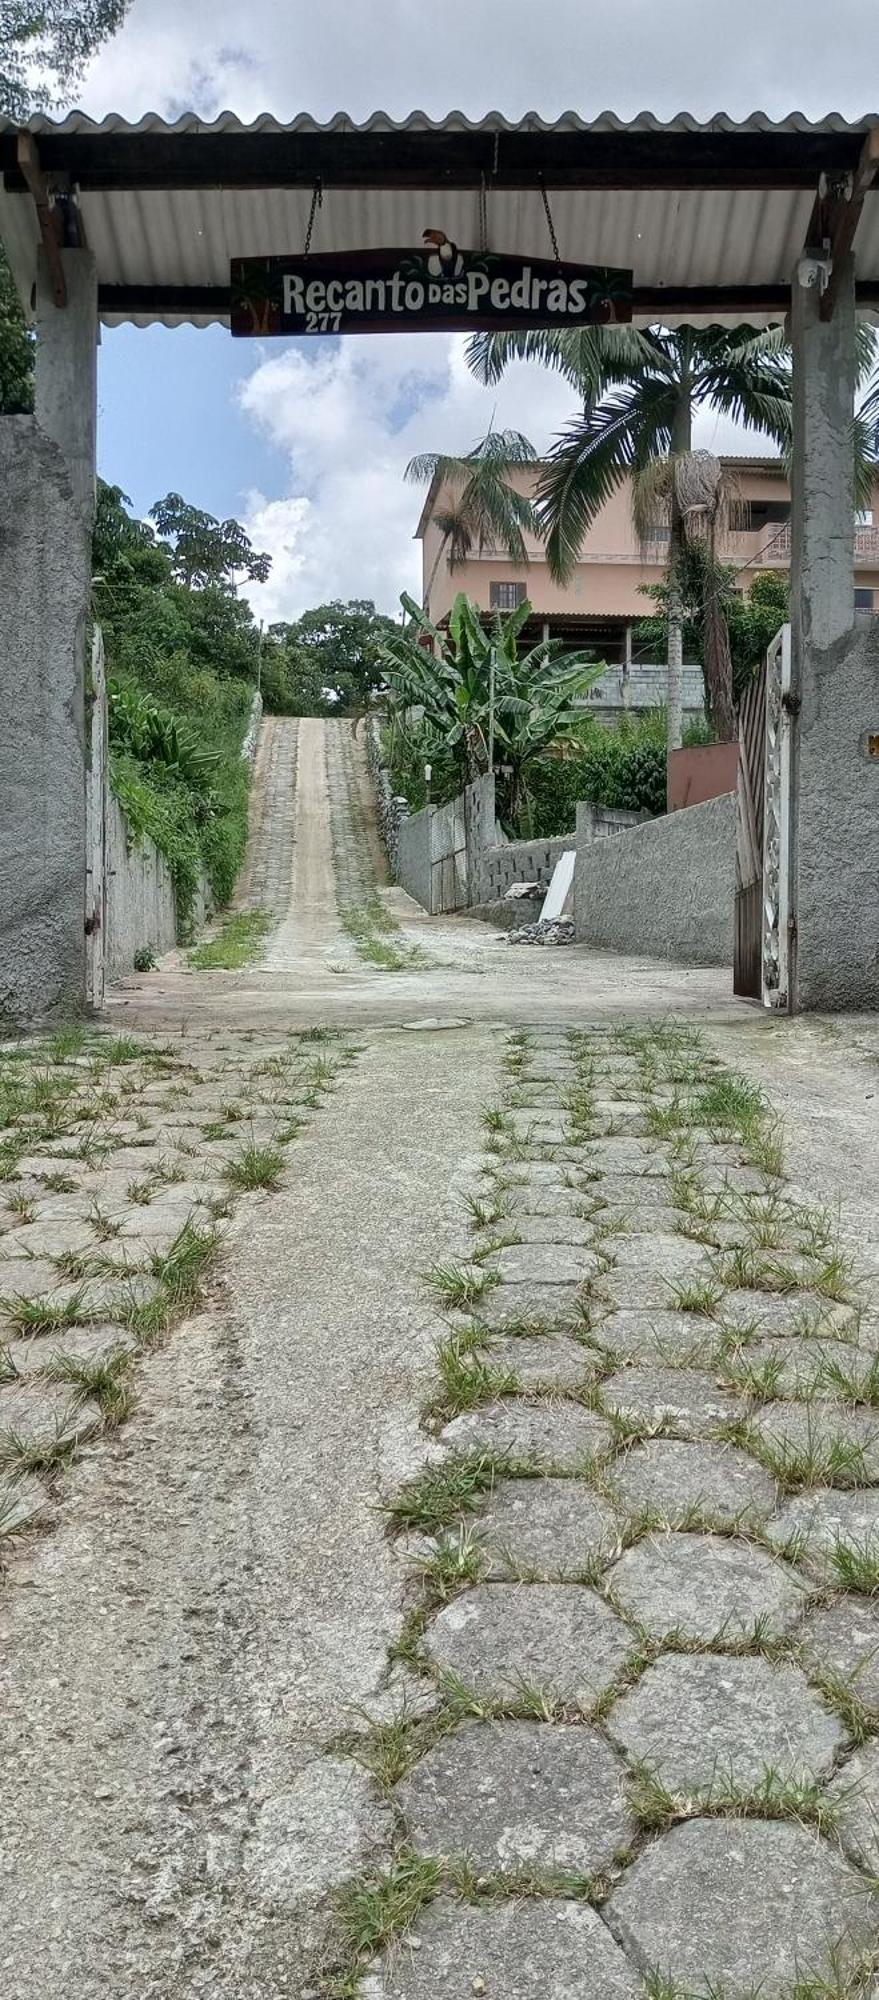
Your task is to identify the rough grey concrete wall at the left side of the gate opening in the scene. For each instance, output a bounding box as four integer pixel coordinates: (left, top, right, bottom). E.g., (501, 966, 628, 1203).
(0, 416, 92, 1024)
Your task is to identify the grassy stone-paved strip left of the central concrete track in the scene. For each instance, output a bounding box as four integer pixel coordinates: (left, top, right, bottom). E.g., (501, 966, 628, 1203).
(0, 1030, 354, 1548)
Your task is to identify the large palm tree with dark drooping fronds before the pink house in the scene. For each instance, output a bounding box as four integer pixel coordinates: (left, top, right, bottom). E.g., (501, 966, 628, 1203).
(467, 326, 791, 750)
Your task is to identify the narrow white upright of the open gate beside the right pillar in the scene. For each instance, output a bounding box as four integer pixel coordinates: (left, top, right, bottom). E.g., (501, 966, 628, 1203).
(763, 626, 791, 1012)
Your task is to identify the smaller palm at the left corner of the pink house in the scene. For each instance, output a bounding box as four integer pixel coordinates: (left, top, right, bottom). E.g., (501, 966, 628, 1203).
(406, 430, 537, 608)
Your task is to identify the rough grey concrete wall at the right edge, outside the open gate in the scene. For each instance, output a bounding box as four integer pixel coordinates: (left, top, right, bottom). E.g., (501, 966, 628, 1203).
(793, 620, 879, 1012)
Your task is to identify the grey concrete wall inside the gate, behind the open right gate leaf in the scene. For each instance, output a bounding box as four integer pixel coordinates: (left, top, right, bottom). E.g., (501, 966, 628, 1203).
(573, 796, 735, 966)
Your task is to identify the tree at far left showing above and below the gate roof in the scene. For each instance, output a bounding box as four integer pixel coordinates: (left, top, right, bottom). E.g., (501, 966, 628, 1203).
(0, 0, 130, 416)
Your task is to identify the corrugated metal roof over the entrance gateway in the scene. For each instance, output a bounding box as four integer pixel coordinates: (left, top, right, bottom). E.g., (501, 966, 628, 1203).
(0, 112, 879, 324)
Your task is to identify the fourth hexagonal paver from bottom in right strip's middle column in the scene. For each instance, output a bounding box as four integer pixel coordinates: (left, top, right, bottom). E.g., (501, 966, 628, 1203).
(607, 1438, 777, 1528)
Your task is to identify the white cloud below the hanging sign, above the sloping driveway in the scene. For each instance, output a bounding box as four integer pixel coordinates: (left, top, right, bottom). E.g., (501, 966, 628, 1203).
(242, 334, 571, 618)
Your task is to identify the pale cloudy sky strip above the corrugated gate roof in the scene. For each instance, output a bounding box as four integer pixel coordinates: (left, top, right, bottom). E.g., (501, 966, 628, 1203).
(84, 0, 879, 118)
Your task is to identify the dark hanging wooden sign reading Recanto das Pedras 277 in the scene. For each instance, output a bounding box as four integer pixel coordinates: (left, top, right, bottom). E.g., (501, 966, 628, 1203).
(232, 230, 631, 338)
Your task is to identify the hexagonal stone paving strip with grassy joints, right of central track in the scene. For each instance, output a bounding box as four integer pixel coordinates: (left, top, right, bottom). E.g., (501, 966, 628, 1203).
(345, 1024, 879, 2000)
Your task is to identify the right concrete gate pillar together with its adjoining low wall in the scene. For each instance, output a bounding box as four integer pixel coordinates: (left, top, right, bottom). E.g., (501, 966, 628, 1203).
(791, 258, 879, 1010)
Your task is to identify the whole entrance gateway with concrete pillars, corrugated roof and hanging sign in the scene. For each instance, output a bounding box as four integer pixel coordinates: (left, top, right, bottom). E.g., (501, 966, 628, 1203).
(0, 112, 879, 1022)
